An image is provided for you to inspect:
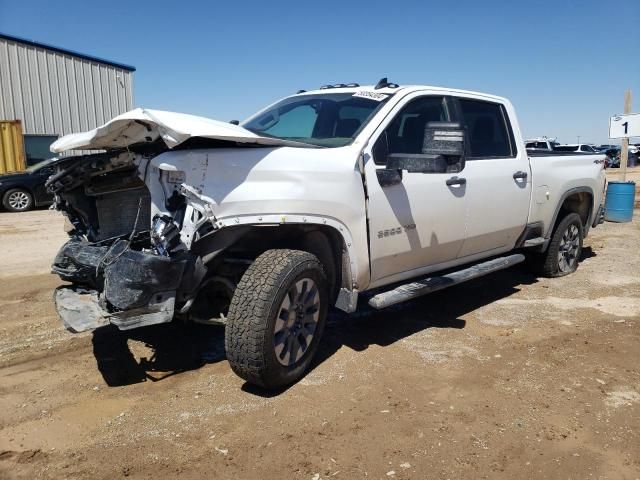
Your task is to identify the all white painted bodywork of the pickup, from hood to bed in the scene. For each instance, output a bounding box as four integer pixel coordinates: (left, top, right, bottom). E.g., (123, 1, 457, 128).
(53, 87, 604, 291)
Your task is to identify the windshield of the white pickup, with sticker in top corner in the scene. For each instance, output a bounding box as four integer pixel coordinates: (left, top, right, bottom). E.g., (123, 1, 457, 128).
(242, 92, 389, 147)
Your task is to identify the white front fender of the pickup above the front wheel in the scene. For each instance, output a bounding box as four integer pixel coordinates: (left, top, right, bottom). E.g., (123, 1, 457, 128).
(146, 146, 369, 285)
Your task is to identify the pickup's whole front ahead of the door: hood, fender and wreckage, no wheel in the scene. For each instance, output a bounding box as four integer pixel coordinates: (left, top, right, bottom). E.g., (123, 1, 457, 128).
(46, 107, 360, 338)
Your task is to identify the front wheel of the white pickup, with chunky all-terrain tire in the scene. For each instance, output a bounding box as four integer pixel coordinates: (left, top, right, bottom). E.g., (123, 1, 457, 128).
(225, 250, 329, 389)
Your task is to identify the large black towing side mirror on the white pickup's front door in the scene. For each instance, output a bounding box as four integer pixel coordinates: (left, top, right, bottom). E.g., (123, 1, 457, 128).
(387, 122, 465, 173)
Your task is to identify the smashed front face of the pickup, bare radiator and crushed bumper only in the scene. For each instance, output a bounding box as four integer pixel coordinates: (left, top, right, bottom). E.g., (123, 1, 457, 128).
(47, 150, 206, 332)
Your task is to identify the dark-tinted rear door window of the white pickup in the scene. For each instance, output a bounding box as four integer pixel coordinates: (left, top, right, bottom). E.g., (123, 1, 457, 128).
(458, 98, 516, 159)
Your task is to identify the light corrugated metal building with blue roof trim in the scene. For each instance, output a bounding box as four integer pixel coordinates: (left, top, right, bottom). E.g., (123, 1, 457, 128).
(0, 33, 135, 168)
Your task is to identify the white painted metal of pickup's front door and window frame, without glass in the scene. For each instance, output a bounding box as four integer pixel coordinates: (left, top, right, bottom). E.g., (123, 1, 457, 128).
(364, 91, 466, 286)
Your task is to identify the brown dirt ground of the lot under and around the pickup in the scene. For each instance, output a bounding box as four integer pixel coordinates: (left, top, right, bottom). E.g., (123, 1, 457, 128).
(0, 210, 640, 480)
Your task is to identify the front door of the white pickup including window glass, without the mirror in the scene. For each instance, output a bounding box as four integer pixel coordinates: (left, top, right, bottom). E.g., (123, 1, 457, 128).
(364, 92, 466, 287)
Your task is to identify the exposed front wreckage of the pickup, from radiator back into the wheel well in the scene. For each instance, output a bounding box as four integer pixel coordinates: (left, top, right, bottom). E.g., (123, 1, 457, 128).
(47, 148, 250, 332)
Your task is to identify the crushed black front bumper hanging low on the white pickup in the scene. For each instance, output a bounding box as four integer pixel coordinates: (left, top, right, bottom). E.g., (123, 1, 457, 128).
(52, 240, 187, 332)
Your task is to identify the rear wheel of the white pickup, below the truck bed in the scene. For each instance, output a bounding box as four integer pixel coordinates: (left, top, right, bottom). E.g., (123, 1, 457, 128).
(529, 213, 584, 277)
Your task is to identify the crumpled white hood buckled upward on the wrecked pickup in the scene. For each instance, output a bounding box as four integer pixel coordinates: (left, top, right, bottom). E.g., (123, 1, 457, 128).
(51, 108, 310, 153)
